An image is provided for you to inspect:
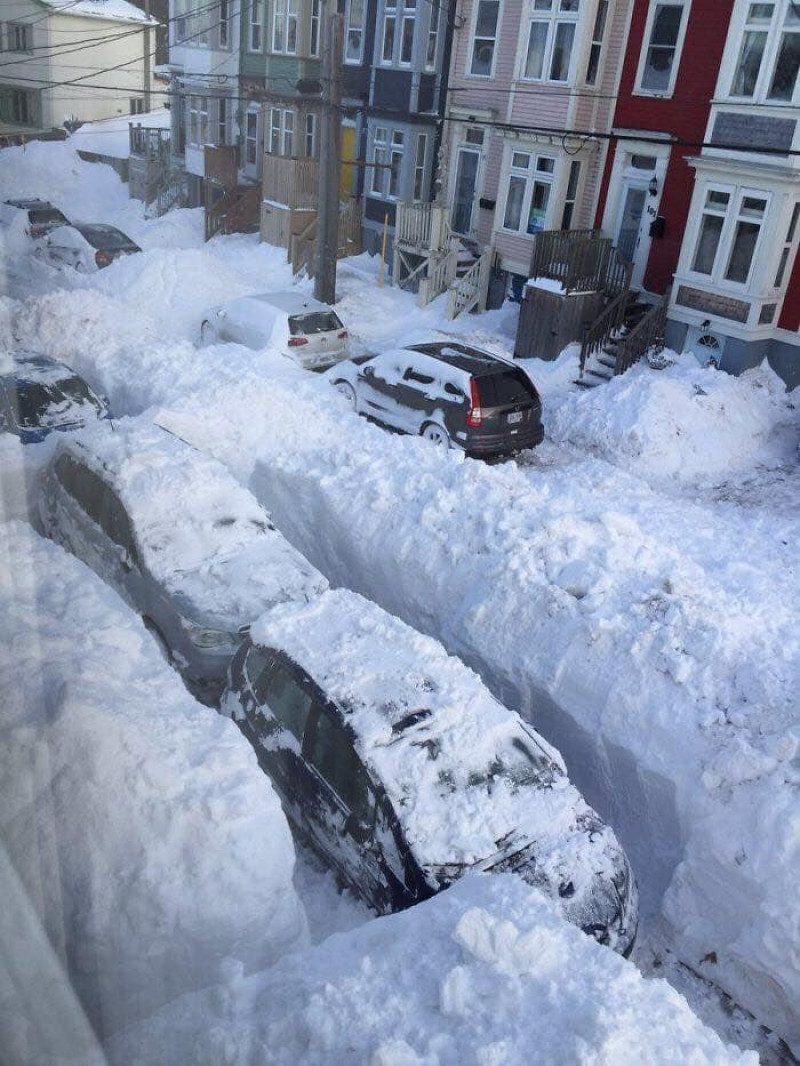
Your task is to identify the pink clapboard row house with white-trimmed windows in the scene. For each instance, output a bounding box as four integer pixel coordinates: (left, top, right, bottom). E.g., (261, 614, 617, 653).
(444, 0, 630, 294)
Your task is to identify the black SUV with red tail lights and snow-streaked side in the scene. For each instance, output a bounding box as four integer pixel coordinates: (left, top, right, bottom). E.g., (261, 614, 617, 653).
(331, 341, 544, 458)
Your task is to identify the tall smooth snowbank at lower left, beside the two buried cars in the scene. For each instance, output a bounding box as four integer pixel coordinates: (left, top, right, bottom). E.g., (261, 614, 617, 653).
(0, 522, 307, 1062)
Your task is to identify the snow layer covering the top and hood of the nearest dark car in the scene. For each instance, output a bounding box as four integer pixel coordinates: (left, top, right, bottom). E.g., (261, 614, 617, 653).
(251, 589, 631, 898)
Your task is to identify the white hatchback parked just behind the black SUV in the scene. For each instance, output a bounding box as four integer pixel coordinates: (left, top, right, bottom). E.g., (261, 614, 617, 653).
(201, 291, 349, 370)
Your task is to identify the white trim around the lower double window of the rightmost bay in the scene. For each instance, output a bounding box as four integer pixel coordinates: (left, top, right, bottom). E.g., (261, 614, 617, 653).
(682, 179, 783, 295)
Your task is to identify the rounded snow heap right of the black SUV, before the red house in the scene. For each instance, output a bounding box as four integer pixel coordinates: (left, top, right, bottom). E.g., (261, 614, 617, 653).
(546, 356, 800, 484)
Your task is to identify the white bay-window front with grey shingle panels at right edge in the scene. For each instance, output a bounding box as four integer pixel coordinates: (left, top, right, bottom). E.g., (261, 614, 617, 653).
(668, 0, 800, 386)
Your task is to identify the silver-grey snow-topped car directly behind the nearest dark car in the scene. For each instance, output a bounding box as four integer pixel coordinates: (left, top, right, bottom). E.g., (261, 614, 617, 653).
(39, 425, 327, 704)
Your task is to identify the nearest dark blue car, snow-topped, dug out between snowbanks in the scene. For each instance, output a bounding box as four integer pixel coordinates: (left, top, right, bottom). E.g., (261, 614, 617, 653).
(222, 589, 638, 953)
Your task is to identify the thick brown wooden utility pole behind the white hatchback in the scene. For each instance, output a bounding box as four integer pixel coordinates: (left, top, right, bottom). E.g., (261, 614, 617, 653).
(314, 8, 345, 304)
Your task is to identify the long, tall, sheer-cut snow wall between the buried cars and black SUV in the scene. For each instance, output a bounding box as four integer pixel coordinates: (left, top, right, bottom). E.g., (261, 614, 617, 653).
(159, 375, 800, 1047)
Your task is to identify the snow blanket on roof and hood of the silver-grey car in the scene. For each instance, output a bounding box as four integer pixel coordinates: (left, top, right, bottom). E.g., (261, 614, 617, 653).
(58, 423, 327, 628)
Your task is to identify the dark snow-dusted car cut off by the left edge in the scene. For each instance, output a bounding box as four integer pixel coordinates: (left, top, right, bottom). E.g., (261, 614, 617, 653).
(0, 352, 109, 445)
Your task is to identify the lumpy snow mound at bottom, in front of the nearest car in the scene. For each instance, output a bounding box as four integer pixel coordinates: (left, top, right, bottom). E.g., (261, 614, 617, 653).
(110, 874, 757, 1066)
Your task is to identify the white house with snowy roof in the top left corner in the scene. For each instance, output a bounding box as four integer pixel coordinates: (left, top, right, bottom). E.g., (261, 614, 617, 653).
(0, 0, 162, 136)
